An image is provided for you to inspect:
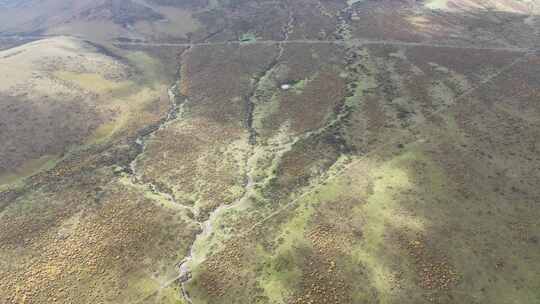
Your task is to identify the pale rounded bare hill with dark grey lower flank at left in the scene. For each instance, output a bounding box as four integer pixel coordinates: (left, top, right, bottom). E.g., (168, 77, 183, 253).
(0, 37, 130, 183)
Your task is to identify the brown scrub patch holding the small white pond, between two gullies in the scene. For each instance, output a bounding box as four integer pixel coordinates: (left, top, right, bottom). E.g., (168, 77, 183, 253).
(254, 44, 346, 139)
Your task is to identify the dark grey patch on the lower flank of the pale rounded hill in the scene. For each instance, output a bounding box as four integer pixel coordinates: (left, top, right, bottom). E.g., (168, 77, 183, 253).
(0, 96, 112, 174)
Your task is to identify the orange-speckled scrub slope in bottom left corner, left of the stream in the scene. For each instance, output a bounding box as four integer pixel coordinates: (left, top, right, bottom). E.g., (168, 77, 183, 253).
(0, 180, 196, 303)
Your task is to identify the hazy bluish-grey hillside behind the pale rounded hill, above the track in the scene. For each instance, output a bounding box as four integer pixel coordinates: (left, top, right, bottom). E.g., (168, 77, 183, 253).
(0, 0, 198, 41)
